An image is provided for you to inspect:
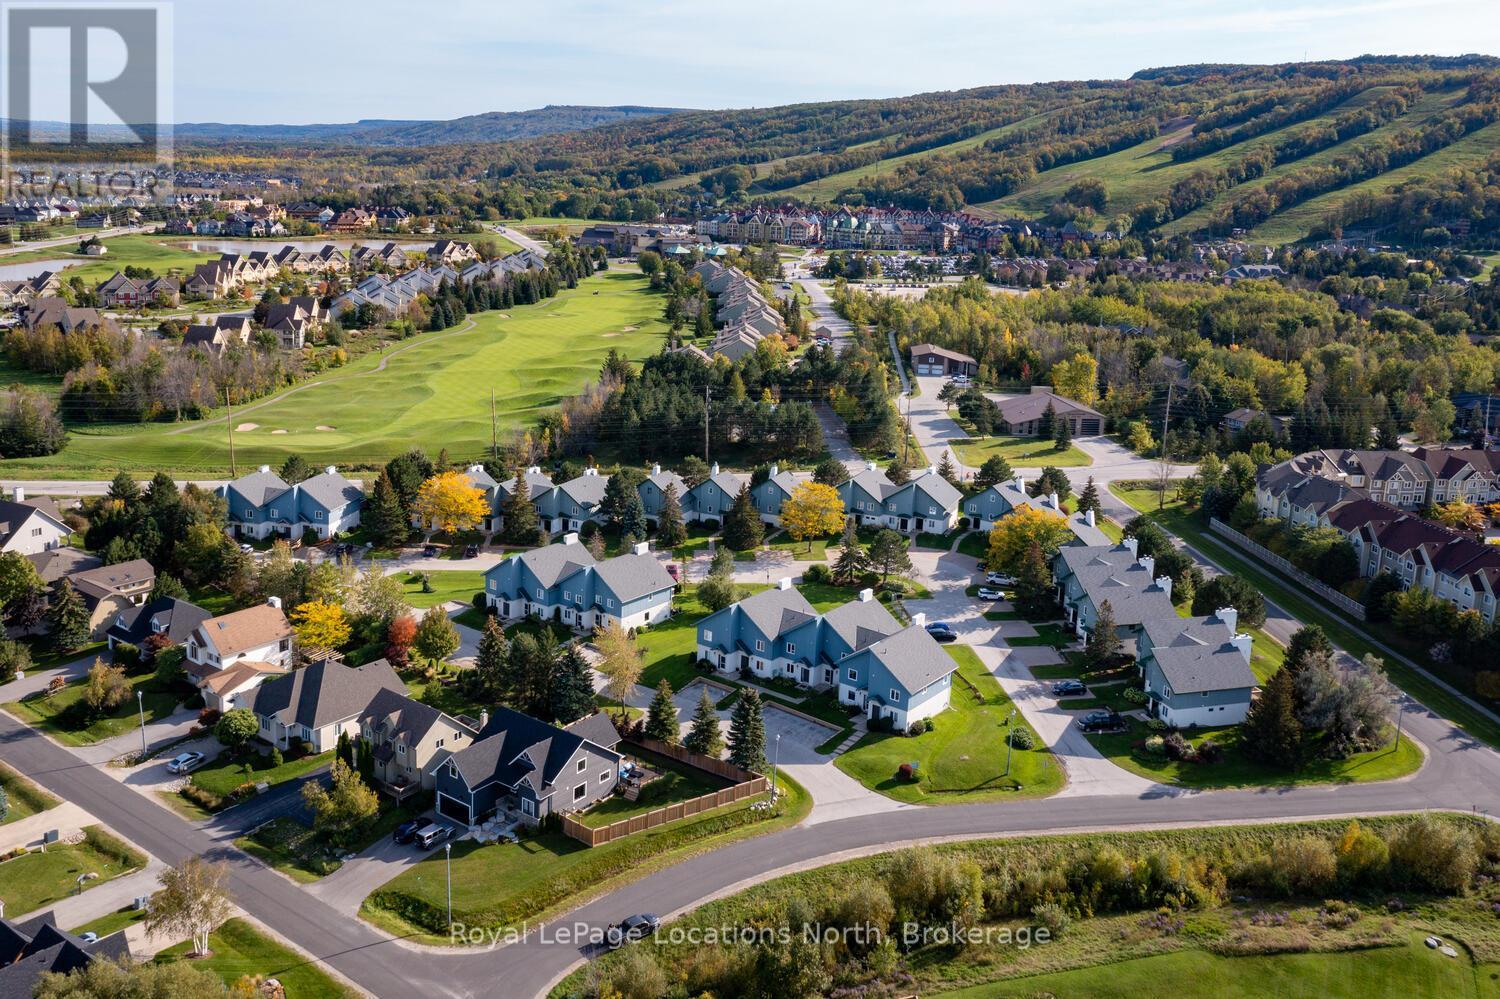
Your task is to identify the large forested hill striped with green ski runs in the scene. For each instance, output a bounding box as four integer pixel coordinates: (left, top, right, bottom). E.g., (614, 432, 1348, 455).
(175, 56, 1500, 242)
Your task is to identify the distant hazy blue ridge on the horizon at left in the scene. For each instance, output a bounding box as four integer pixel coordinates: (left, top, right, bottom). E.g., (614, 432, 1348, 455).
(176, 104, 678, 146)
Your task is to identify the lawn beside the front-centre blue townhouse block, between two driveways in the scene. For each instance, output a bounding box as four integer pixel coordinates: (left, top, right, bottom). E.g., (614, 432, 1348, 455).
(834, 645, 1064, 804)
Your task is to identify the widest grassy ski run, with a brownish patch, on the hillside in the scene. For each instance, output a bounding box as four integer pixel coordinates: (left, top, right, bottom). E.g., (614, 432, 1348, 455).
(974, 87, 1410, 218)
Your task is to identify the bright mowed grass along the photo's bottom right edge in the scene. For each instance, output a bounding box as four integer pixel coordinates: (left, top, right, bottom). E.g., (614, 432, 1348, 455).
(939, 935, 1496, 999)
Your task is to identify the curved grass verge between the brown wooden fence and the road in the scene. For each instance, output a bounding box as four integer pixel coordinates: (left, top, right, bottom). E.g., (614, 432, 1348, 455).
(360, 776, 813, 944)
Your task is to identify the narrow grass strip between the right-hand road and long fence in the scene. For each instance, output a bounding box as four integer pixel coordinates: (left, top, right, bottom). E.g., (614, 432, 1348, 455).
(1110, 485, 1500, 746)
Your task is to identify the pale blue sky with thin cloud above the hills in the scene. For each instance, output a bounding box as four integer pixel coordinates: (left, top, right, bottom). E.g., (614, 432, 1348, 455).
(173, 0, 1500, 125)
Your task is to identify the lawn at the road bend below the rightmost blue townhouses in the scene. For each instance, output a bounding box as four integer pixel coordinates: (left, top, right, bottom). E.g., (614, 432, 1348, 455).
(1089, 719, 1422, 789)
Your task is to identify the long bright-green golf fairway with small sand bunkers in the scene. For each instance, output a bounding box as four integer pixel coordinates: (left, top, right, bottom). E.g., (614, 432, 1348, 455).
(8, 270, 666, 476)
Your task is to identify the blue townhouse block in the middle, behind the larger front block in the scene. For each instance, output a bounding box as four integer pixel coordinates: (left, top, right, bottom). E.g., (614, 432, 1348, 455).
(485, 534, 677, 632)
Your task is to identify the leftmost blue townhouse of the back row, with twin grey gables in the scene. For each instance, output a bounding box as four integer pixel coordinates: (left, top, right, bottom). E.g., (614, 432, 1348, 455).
(218, 465, 365, 542)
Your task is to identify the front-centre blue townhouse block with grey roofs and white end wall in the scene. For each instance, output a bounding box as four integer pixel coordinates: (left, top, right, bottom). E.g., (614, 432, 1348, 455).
(698, 579, 957, 729)
